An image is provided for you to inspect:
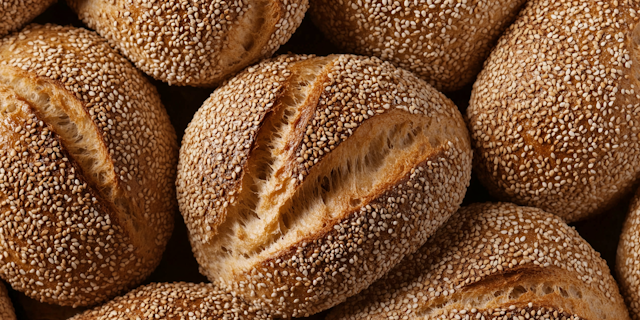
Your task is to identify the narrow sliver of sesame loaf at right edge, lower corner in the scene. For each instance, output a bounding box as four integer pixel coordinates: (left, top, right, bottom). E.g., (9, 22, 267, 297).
(616, 186, 640, 320)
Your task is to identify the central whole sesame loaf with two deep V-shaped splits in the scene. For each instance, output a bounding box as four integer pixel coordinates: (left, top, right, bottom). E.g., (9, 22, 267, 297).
(177, 55, 471, 317)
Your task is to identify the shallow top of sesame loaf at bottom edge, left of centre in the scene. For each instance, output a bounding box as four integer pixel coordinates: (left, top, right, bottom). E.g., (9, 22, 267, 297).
(69, 282, 271, 320)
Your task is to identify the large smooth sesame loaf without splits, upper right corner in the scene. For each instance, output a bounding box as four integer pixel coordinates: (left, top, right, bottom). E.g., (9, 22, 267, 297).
(467, 0, 640, 222)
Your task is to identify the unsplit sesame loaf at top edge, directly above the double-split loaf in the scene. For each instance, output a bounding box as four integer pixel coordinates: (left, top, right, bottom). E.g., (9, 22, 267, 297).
(309, 0, 525, 91)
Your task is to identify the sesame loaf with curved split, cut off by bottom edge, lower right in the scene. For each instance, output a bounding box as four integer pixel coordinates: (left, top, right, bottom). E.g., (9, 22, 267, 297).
(328, 203, 629, 320)
